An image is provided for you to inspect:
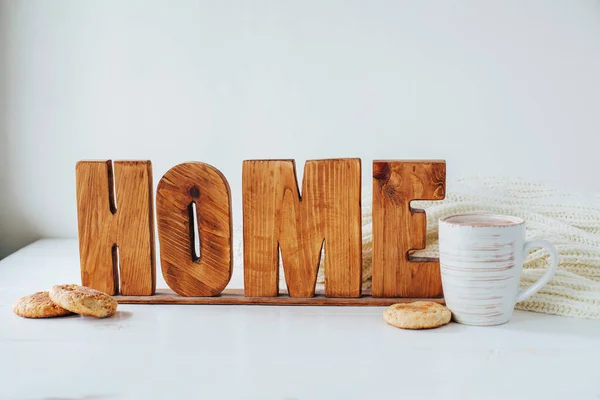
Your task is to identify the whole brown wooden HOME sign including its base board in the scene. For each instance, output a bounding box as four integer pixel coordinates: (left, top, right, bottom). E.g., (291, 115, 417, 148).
(76, 158, 446, 305)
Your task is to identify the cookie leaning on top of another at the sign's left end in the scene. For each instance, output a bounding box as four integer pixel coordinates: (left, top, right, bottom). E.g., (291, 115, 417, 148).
(50, 285, 117, 318)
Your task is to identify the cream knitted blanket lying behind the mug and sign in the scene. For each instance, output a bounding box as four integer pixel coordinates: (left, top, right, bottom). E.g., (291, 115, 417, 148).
(234, 178, 600, 319)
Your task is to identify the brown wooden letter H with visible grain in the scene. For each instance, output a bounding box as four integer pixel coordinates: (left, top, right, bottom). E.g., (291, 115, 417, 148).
(76, 161, 156, 296)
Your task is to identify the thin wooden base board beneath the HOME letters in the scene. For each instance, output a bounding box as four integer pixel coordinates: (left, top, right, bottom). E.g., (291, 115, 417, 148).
(114, 289, 444, 306)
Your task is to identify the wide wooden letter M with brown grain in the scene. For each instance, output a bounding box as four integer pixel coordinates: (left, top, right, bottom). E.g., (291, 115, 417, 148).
(242, 159, 362, 297)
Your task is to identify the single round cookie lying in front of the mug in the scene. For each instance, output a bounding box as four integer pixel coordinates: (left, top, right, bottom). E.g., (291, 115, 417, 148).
(383, 301, 452, 329)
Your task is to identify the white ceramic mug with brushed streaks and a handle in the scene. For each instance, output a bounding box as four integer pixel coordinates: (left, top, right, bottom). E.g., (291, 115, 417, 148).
(439, 213, 558, 325)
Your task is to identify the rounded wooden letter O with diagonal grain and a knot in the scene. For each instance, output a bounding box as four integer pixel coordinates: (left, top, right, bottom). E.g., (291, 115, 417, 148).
(156, 162, 233, 296)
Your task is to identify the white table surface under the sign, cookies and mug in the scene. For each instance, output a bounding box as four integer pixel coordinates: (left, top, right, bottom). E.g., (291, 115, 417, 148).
(0, 239, 600, 400)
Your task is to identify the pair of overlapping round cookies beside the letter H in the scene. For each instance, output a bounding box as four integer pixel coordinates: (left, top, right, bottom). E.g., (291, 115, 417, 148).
(13, 285, 117, 318)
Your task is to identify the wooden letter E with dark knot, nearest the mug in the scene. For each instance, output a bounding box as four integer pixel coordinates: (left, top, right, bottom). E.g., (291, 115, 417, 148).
(372, 160, 446, 297)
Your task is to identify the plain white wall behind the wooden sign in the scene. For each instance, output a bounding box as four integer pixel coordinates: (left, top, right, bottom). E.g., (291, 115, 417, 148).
(0, 0, 600, 258)
